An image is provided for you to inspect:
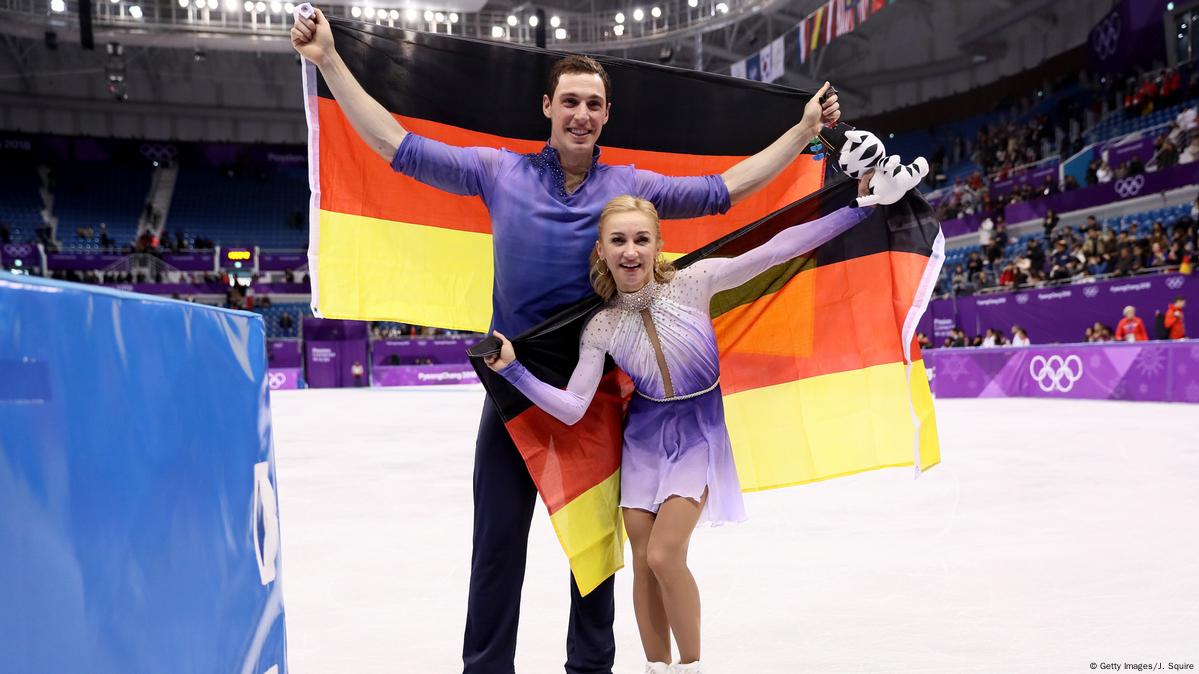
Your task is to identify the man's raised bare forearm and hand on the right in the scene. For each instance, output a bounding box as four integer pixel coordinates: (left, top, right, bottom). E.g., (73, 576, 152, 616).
(721, 82, 840, 204)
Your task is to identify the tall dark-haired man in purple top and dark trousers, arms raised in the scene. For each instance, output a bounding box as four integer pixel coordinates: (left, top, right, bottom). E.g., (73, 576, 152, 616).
(291, 10, 840, 674)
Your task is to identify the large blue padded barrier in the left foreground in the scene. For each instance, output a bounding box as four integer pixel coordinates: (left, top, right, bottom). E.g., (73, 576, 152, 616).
(0, 272, 287, 674)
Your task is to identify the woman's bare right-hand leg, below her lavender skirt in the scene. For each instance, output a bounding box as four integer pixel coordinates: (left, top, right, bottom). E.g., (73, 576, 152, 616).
(646, 491, 707, 664)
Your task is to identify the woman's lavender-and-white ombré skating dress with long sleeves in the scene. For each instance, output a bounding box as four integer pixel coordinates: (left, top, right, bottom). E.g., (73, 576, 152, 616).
(501, 209, 869, 524)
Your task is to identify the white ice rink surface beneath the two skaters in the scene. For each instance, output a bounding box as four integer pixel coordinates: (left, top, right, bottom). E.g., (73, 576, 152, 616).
(271, 387, 1199, 674)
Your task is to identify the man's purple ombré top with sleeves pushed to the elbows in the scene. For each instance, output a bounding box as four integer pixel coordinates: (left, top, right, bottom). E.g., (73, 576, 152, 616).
(391, 133, 730, 337)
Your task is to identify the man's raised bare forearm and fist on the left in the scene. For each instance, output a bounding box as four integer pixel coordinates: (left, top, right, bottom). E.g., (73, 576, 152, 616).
(291, 10, 408, 162)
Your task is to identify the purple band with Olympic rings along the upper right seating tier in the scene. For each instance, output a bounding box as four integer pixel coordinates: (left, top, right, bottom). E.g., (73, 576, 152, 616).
(941, 160, 1199, 239)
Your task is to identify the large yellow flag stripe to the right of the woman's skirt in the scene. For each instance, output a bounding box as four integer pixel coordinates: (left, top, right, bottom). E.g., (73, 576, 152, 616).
(724, 361, 941, 492)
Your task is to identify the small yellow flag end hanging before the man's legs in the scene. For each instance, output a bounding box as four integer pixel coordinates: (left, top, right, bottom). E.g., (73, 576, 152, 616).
(549, 470, 625, 595)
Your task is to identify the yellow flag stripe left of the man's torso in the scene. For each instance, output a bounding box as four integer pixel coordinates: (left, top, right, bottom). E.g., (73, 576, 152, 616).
(315, 210, 494, 332)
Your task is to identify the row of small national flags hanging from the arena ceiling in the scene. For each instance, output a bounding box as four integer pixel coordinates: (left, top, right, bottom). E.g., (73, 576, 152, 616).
(729, 0, 896, 82)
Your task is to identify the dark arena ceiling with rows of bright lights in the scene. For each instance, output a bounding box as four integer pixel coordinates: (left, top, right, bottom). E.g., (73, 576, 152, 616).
(0, 0, 1110, 140)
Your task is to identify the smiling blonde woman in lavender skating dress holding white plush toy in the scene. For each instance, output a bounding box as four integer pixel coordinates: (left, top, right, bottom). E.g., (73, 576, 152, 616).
(487, 157, 927, 673)
